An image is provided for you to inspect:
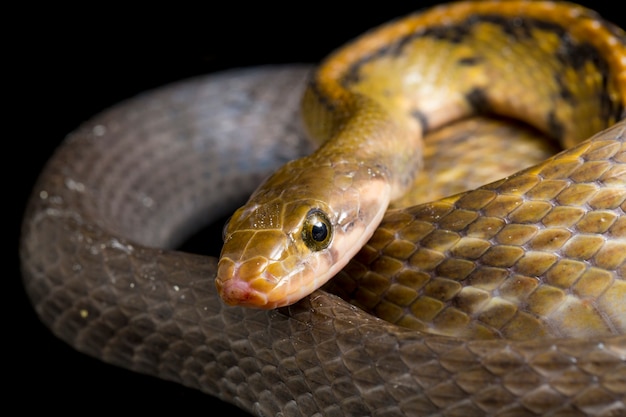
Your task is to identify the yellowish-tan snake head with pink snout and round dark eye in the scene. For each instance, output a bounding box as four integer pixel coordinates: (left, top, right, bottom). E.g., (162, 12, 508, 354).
(216, 158, 389, 309)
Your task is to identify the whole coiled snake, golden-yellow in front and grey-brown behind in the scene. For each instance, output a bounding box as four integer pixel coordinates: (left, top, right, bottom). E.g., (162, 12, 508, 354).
(20, 1, 626, 416)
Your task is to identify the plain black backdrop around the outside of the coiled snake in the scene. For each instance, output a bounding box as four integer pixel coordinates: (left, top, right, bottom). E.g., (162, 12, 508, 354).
(12, 1, 626, 416)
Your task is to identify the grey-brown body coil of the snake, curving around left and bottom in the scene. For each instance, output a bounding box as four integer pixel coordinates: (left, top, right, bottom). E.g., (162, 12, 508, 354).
(22, 0, 626, 415)
